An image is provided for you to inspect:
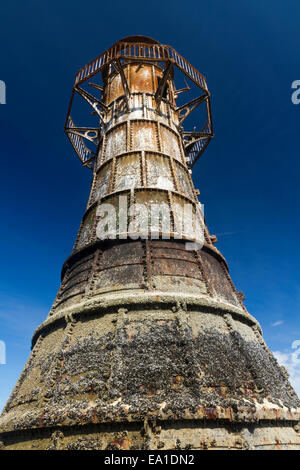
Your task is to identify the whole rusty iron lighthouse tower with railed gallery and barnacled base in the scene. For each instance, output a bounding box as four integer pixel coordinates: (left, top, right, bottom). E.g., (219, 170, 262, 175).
(0, 36, 300, 449)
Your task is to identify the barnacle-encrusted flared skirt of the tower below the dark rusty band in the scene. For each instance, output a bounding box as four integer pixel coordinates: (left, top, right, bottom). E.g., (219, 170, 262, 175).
(1, 284, 299, 448)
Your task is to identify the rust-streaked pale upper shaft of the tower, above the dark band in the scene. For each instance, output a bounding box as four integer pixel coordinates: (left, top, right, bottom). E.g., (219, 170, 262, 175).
(67, 47, 208, 246)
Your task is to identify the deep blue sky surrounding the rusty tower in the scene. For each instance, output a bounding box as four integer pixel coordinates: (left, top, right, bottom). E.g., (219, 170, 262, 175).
(0, 0, 300, 409)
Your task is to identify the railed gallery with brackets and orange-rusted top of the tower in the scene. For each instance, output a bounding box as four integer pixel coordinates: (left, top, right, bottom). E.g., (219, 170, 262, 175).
(65, 36, 213, 168)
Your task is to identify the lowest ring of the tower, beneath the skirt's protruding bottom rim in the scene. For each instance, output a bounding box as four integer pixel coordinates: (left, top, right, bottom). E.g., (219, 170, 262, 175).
(2, 420, 300, 450)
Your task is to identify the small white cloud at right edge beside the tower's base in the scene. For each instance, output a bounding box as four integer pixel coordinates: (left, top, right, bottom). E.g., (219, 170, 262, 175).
(273, 340, 300, 397)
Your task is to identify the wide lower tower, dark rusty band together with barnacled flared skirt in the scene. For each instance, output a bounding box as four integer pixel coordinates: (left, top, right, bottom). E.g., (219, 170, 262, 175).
(0, 241, 300, 449)
